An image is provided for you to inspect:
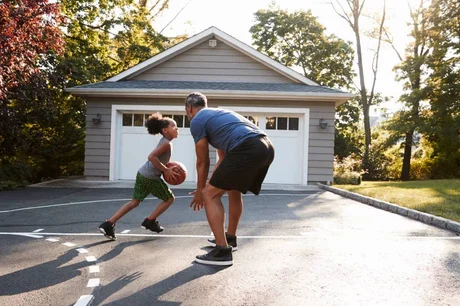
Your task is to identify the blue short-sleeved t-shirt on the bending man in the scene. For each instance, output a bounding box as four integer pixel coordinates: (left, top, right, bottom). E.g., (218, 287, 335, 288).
(190, 108, 267, 153)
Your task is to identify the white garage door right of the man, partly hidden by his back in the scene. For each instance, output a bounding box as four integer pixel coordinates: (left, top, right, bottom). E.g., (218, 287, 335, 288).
(241, 113, 303, 184)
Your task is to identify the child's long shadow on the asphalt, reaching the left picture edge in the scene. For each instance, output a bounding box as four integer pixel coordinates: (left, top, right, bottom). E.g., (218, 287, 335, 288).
(0, 239, 148, 296)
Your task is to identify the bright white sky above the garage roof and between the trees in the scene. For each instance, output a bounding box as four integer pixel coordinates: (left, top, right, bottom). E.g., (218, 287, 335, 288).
(155, 0, 418, 115)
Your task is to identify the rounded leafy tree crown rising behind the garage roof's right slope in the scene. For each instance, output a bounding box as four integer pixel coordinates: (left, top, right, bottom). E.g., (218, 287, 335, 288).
(249, 9, 354, 89)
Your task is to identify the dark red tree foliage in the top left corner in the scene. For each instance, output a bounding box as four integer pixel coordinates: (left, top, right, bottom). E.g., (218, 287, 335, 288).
(0, 0, 64, 98)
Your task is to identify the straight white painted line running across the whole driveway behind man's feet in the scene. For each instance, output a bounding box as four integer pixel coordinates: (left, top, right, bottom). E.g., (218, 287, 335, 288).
(0, 232, 460, 240)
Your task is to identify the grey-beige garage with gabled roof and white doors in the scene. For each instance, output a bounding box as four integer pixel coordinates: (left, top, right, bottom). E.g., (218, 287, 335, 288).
(70, 27, 354, 184)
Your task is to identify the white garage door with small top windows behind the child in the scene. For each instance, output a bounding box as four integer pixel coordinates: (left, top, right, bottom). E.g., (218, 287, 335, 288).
(116, 111, 196, 182)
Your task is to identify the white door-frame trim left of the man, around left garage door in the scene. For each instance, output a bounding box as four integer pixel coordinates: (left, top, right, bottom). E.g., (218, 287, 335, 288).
(109, 104, 185, 181)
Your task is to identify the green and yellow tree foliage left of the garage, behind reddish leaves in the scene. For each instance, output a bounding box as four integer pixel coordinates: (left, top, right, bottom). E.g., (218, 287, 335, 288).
(0, 0, 176, 186)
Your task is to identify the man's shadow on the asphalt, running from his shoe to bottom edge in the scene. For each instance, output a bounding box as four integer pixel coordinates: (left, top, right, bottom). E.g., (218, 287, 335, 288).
(93, 263, 228, 306)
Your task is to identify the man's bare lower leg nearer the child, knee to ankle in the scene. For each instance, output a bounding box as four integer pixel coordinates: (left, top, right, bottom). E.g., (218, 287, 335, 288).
(203, 184, 227, 246)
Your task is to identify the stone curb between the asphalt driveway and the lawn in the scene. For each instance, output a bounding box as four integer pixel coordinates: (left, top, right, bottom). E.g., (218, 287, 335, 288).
(318, 184, 460, 234)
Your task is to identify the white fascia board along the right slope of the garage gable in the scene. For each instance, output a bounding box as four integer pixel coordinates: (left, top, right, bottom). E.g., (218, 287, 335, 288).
(213, 28, 319, 86)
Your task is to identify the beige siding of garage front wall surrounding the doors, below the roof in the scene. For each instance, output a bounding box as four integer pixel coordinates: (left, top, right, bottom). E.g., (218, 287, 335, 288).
(85, 98, 335, 183)
